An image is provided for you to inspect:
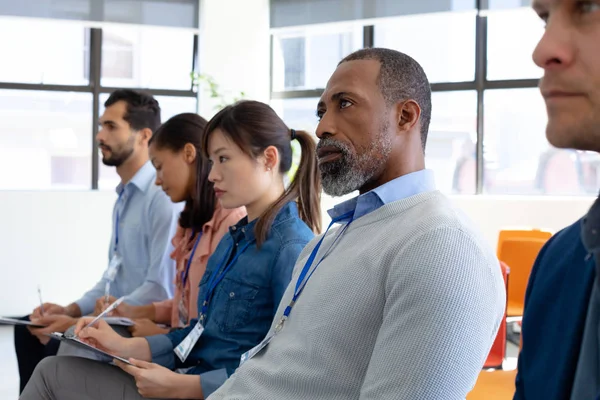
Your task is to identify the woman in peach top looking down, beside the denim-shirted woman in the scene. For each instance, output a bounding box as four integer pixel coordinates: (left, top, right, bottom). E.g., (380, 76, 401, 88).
(113, 113, 246, 337)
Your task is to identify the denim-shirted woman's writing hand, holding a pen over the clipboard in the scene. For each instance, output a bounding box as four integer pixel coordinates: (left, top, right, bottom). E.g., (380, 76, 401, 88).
(73, 317, 128, 356)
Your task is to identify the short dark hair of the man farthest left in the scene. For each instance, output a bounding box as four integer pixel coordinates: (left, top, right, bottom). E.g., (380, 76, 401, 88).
(104, 89, 160, 132)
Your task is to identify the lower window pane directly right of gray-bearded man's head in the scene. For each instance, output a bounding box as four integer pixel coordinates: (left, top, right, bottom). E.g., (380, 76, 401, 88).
(425, 91, 477, 194)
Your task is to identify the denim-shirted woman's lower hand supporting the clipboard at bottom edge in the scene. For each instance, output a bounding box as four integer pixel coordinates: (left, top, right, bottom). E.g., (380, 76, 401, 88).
(115, 358, 204, 399)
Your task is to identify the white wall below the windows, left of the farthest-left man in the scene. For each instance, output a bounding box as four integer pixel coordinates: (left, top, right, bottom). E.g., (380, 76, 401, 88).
(0, 191, 116, 316)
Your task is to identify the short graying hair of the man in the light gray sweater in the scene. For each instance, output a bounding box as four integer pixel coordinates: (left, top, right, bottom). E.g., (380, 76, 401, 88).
(338, 48, 431, 150)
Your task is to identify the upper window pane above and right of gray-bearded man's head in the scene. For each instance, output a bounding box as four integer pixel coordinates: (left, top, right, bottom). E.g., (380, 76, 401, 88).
(375, 12, 476, 83)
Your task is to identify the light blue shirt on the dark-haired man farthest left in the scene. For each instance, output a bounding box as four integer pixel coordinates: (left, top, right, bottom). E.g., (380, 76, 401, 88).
(76, 161, 183, 315)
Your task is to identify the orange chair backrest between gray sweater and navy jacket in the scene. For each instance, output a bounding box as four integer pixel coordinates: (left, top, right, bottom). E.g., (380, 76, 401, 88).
(498, 230, 552, 317)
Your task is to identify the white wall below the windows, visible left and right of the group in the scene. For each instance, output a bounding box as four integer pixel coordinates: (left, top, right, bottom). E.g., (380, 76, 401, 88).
(0, 191, 594, 315)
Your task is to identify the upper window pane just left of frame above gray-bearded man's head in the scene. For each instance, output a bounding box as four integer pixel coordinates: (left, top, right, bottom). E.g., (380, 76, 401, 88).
(273, 26, 363, 92)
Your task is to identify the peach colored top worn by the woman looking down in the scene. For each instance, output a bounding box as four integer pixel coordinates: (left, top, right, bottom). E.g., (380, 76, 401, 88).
(154, 202, 246, 327)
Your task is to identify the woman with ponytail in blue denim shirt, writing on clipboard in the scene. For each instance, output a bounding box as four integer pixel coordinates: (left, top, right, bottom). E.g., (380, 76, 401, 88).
(21, 101, 321, 400)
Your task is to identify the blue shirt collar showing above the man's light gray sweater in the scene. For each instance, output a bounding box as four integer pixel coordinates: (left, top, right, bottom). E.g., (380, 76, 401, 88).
(327, 169, 435, 220)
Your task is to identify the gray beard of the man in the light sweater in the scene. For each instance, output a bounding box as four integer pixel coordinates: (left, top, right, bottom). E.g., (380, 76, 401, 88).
(319, 131, 391, 197)
